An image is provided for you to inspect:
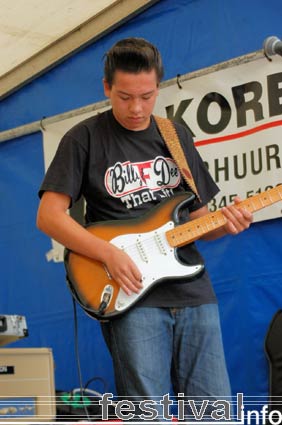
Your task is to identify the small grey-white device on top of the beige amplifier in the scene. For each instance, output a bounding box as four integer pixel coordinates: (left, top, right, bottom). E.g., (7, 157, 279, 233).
(0, 315, 28, 346)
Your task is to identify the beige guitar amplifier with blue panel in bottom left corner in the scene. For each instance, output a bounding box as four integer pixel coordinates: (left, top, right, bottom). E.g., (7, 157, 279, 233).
(0, 348, 56, 423)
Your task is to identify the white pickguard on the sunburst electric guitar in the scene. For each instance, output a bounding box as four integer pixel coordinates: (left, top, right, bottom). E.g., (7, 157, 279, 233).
(111, 221, 202, 311)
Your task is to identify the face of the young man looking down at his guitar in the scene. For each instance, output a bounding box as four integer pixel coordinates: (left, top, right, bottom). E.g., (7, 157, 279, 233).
(104, 70, 159, 131)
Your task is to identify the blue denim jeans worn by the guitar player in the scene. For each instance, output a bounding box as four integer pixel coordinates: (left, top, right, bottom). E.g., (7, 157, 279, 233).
(102, 304, 231, 420)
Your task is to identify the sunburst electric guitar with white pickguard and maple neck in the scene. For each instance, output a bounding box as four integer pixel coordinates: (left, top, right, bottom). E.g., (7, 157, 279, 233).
(65, 185, 282, 320)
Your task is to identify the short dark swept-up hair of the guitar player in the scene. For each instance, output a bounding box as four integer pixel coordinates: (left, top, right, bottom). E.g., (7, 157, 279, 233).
(104, 37, 163, 87)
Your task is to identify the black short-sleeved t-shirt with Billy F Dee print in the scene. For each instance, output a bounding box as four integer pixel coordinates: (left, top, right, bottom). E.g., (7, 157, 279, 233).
(39, 110, 218, 307)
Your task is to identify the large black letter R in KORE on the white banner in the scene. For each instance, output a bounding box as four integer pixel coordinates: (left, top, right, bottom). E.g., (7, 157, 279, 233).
(232, 81, 264, 127)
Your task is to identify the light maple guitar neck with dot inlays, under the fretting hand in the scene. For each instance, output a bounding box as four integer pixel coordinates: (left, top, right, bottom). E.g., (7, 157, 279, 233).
(166, 185, 282, 248)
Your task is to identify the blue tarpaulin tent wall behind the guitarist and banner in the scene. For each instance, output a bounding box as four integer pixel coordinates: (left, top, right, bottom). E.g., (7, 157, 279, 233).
(0, 0, 282, 395)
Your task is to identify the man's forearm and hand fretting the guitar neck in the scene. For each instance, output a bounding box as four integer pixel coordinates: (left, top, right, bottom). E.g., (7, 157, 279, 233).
(190, 197, 253, 240)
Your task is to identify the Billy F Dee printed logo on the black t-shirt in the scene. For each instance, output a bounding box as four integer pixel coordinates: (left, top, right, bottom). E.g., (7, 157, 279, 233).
(105, 156, 180, 208)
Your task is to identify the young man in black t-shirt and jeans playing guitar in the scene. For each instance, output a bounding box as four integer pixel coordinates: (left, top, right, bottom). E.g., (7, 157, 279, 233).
(37, 38, 252, 420)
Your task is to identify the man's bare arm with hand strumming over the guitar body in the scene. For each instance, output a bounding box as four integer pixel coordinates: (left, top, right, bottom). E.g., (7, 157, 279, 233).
(36, 191, 142, 294)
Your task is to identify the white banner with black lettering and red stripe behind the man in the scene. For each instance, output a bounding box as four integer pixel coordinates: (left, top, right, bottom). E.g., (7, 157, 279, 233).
(43, 57, 282, 261)
